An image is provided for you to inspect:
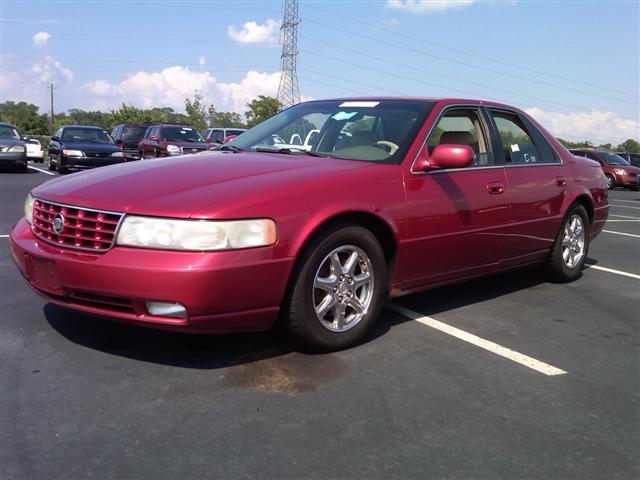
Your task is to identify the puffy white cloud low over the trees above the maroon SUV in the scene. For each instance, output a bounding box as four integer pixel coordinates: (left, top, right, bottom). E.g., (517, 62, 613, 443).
(82, 66, 216, 111)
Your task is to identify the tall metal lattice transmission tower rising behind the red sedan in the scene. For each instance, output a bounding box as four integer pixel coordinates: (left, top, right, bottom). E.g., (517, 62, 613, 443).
(278, 0, 300, 109)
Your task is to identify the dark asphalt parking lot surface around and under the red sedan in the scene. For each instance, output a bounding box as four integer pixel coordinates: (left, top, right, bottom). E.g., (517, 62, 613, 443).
(0, 164, 640, 479)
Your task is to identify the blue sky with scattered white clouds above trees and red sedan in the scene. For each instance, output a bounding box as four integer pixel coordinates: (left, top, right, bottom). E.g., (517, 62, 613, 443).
(0, 0, 640, 143)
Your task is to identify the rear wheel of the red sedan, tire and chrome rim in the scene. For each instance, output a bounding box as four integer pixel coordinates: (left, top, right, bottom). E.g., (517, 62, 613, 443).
(546, 205, 589, 282)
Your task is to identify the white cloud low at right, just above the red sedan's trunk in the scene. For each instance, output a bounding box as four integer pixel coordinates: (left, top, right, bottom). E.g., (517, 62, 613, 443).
(526, 107, 640, 145)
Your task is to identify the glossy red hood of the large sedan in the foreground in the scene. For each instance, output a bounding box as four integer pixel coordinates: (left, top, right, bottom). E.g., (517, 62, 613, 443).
(32, 152, 376, 218)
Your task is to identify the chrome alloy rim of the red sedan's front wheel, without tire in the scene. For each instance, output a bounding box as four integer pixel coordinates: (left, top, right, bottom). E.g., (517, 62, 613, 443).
(313, 245, 374, 333)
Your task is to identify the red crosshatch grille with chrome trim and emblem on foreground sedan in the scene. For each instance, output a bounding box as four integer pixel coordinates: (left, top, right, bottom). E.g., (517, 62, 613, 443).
(31, 199, 123, 252)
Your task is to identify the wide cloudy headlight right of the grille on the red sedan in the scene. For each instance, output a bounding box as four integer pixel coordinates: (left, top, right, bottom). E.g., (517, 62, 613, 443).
(116, 216, 277, 251)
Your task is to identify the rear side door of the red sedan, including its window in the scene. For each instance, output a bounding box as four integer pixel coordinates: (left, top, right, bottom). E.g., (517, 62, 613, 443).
(488, 108, 569, 262)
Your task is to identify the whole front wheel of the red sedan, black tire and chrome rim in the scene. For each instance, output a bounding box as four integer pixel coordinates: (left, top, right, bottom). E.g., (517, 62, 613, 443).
(284, 225, 387, 351)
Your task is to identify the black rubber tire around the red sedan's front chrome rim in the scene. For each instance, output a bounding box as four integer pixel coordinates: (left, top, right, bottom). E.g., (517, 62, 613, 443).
(283, 225, 387, 352)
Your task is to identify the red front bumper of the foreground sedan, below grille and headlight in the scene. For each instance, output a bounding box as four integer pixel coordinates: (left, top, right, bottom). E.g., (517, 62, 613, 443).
(10, 219, 295, 333)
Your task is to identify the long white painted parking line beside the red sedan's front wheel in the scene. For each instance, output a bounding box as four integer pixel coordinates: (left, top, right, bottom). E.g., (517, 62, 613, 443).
(385, 303, 567, 376)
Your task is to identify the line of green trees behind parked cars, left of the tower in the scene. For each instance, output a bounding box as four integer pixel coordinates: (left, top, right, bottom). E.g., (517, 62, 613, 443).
(0, 92, 281, 136)
